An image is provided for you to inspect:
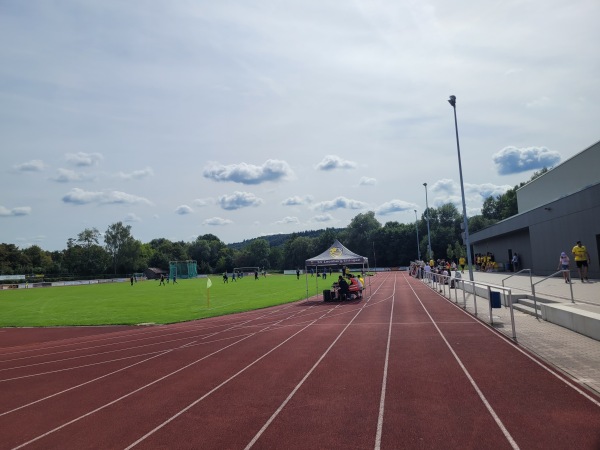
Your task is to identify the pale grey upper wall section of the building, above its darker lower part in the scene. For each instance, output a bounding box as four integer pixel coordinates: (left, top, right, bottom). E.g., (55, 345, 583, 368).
(517, 141, 600, 213)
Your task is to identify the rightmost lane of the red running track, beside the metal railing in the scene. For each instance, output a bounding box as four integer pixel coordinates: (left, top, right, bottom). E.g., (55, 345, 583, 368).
(408, 276, 600, 448)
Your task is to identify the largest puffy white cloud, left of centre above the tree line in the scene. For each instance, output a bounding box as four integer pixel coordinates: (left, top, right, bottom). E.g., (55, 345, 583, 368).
(202, 159, 293, 184)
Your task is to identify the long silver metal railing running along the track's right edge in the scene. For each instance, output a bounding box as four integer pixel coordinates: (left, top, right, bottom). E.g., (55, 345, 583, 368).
(422, 272, 517, 341)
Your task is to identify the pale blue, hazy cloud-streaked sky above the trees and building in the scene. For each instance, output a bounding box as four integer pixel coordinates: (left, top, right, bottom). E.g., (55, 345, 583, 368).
(0, 0, 600, 251)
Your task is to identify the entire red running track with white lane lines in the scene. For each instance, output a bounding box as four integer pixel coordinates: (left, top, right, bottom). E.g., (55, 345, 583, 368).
(0, 272, 600, 449)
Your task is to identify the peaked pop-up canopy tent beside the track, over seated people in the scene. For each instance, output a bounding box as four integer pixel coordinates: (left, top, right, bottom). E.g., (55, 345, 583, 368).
(304, 239, 371, 301)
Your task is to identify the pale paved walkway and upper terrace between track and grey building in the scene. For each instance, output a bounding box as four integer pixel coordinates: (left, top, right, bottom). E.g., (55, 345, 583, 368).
(422, 271, 600, 394)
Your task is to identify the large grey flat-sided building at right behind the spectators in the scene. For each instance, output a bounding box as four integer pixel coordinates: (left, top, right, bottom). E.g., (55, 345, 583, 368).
(470, 141, 600, 279)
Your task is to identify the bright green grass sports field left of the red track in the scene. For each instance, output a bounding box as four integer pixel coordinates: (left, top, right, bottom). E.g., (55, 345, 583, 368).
(0, 275, 333, 327)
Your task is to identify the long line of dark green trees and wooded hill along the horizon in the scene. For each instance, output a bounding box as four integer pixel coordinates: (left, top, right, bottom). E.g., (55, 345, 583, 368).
(0, 168, 547, 278)
